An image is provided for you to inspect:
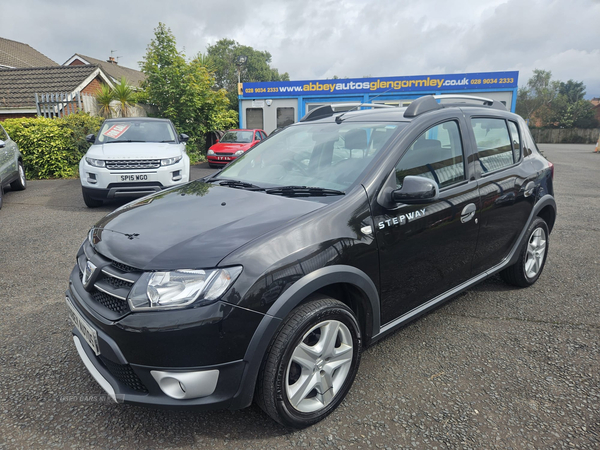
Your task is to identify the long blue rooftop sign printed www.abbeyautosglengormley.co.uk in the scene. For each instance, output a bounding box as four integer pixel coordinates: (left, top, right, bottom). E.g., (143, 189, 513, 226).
(242, 72, 519, 97)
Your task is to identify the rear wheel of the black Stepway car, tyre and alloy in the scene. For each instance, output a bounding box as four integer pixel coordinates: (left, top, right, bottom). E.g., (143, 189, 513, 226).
(500, 217, 550, 287)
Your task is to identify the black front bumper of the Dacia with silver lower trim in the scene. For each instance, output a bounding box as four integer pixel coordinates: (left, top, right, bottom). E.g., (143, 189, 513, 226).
(66, 260, 264, 409)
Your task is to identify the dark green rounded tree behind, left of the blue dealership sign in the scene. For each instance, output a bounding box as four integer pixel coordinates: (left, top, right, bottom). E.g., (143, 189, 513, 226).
(207, 39, 290, 111)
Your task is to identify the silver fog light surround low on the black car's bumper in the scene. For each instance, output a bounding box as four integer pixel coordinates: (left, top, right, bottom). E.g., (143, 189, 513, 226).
(150, 370, 219, 400)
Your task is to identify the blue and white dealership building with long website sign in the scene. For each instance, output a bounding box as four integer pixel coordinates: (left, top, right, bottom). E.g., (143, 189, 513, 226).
(238, 72, 519, 133)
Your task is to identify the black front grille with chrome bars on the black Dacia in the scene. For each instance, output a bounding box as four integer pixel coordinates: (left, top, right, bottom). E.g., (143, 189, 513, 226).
(78, 242, 142, 320)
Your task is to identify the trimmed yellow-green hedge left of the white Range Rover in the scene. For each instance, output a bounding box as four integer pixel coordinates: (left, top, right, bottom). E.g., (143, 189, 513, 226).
(3, 113, 104, 179)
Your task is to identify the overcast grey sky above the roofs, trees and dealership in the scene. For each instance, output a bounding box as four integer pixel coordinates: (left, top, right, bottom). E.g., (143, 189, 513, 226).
(0, 0, 600, 98)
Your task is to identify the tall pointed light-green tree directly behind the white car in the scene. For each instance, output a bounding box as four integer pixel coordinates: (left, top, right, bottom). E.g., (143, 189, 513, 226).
(140, 23, 237, 156)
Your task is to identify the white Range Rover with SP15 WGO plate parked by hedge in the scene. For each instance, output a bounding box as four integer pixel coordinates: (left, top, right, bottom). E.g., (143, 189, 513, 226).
(79, 117, 190, 208)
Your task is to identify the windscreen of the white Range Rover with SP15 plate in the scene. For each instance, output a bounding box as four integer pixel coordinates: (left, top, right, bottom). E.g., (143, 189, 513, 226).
(96, 120, 175, 144)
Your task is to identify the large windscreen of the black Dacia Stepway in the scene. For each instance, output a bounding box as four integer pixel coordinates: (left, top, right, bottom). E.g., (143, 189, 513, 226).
(218, 122, 405, 191)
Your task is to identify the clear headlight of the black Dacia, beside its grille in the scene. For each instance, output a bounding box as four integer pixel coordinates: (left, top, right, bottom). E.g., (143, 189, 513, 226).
(128, 266, 242, 311)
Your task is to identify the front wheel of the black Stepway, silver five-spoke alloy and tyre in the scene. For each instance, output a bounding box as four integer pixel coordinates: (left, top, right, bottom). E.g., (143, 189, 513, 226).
(256, 298, 362, 428)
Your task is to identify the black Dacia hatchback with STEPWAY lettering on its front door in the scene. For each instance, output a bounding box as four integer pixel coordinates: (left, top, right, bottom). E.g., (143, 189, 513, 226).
(67, 96, 556, 428)
